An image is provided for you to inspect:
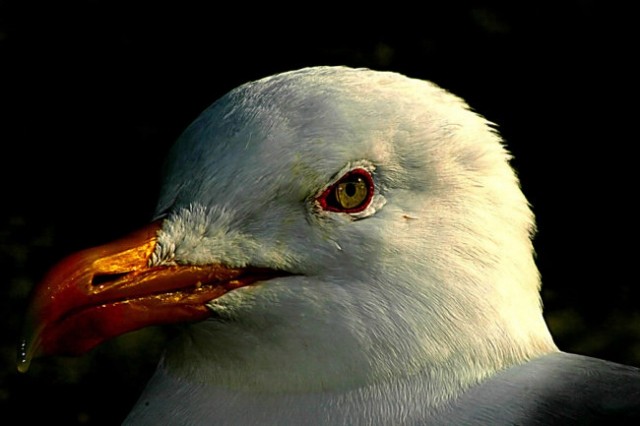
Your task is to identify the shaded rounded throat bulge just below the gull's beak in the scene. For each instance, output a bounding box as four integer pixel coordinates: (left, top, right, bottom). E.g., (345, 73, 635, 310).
(163, 315, 380, 394)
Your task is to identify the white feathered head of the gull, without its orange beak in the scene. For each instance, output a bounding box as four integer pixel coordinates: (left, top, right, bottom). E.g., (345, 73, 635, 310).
(153, 67, 555, 397)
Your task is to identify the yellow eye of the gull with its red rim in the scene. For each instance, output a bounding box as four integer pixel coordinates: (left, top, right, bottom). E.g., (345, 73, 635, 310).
(317, 168, 373, 213)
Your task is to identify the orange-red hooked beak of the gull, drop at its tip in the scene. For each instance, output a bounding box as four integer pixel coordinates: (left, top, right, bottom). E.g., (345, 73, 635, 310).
(18, 221, 283, 371)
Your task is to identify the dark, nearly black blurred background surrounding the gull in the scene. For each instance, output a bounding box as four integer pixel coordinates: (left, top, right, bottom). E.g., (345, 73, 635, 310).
(0, 0, 640, 425)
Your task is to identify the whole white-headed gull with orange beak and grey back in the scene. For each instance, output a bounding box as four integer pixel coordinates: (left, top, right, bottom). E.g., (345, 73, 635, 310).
(18, 66, 640, 425)
